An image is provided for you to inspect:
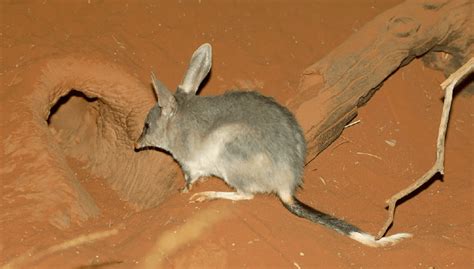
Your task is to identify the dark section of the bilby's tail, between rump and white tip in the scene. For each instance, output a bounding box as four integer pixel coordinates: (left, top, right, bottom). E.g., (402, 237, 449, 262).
(282, 197, 363, 235)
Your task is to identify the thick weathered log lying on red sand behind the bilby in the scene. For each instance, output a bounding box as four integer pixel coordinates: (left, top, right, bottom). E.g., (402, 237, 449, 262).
(288, 0, 474, 162)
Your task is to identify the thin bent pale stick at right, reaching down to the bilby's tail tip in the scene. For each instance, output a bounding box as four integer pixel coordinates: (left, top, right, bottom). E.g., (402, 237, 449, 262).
(376, 58, 474, 239)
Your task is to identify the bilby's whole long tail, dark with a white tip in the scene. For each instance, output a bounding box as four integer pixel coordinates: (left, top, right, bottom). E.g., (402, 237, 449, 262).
(282, 197, 412, 247)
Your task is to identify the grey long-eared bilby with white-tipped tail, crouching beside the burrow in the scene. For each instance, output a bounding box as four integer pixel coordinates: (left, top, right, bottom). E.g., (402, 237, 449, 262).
(135, 44, 411, 247)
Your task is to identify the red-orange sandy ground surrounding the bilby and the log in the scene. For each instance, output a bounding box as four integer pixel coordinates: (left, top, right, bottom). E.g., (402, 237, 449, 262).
(0, 0, 474, 268)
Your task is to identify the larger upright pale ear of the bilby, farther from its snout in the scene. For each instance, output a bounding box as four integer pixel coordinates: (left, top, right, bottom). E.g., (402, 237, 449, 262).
(179, 43, 212, 94)
